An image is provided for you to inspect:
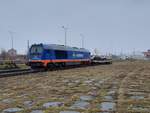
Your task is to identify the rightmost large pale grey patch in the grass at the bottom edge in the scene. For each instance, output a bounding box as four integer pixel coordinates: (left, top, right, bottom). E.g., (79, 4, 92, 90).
(100, 102, 116, 111)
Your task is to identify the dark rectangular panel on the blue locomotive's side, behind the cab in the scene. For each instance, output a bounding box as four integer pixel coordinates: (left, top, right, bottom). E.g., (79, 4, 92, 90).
(55, 50, 67, 59)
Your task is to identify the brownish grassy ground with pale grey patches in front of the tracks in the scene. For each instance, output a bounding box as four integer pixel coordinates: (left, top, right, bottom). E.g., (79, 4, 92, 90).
(0, 61, 150, 113)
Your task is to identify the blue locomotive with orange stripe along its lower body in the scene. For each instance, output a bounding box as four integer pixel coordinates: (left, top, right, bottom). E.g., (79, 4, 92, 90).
(28, 44, 91, 68)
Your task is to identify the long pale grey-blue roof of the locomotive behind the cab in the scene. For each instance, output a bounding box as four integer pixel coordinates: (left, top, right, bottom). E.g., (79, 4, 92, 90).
(32, 44, 89, 52)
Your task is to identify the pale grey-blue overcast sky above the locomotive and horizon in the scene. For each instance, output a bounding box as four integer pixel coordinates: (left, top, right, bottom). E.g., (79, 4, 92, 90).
(0, 0, 150, 53)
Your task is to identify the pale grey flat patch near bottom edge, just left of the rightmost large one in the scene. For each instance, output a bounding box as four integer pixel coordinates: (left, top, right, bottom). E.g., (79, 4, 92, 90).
(70, 101, 90, 109)
